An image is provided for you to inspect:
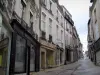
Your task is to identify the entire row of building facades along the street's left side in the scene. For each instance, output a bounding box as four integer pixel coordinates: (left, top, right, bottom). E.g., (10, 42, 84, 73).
(0, 0, 80, 75)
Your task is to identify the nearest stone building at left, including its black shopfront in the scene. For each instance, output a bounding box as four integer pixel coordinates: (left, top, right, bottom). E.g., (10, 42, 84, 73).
(0, 0, 40, 75)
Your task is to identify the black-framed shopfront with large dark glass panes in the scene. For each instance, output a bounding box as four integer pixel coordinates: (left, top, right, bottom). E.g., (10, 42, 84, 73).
(10, 19, 40, 75)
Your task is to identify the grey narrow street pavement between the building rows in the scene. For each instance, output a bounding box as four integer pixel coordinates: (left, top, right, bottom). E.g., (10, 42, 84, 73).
(33, 58, 100, 75)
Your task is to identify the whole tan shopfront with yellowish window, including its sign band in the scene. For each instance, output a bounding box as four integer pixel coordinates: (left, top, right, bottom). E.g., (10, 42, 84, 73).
(40, 39, 56, 70)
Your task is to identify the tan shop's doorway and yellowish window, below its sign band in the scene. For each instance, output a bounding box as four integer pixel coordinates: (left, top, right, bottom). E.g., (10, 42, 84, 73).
(40, 48, 55, 69)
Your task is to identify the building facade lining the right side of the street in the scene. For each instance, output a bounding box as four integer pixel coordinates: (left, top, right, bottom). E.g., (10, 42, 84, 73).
(88, 0, 100, 65)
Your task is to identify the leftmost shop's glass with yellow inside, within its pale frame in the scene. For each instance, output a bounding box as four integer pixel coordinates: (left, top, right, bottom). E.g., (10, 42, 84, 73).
(0, 15, 9, 75)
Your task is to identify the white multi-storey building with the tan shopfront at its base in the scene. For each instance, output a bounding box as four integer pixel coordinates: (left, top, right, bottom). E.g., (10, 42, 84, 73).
(40, 0, 65, 69)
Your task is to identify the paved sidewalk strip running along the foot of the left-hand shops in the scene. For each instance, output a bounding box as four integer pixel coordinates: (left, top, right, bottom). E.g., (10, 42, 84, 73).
(30, 62, 79, 75)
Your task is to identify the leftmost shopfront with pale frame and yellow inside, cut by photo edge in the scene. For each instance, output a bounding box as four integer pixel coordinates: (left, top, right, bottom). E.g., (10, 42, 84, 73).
(0, 11, 12, 75)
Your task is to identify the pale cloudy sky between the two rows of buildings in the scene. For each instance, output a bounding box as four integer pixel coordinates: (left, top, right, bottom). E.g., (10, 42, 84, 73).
(59, 0, 91, 51)
